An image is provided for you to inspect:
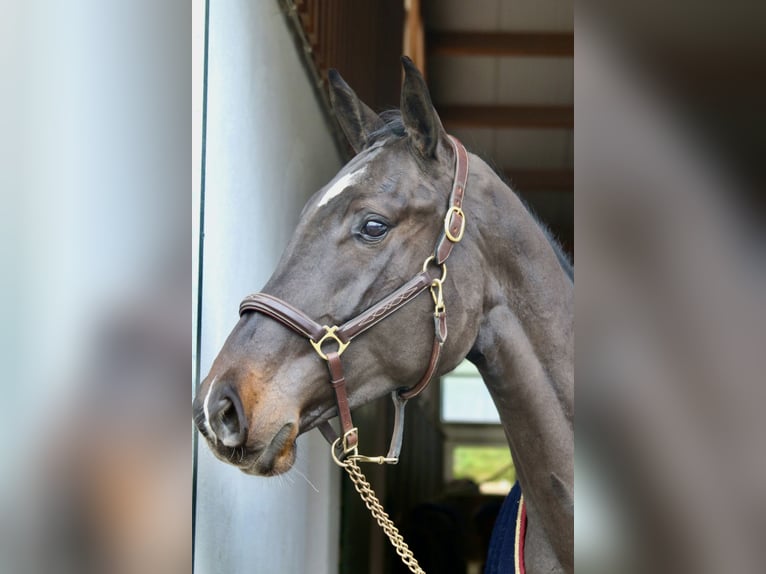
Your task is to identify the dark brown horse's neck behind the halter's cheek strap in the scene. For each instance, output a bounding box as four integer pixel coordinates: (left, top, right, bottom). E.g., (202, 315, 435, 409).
(469, 161, 574, 570)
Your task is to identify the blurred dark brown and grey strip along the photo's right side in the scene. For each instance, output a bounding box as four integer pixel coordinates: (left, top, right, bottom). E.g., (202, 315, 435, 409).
(575, 1, 766, 573)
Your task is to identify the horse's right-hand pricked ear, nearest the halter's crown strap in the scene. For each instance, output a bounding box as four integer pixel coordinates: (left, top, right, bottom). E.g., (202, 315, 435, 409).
(401, 56, 447, 158)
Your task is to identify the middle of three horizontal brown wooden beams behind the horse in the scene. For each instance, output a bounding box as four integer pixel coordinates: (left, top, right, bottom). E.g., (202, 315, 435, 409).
(436, 105, 574, 129)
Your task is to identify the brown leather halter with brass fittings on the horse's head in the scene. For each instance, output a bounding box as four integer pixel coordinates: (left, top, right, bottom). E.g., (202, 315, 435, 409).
(239, 136, 468, 464)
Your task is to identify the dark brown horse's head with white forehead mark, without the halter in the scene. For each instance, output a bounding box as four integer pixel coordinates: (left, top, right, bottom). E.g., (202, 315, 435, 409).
(194, 58, 483, 475)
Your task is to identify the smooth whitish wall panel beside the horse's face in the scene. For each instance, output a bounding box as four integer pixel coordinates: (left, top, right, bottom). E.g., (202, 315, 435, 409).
(194, 0, 340, 574)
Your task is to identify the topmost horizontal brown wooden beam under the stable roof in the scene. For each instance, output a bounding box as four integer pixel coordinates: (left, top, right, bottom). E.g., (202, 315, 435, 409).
(426, 30, 574, 56)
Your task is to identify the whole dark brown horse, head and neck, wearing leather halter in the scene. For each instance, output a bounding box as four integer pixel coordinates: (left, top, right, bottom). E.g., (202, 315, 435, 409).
(194, 57, 574, 574)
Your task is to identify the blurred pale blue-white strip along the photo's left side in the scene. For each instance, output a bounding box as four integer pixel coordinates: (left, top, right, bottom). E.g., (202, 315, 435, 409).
(0, 0, 192, 574)
